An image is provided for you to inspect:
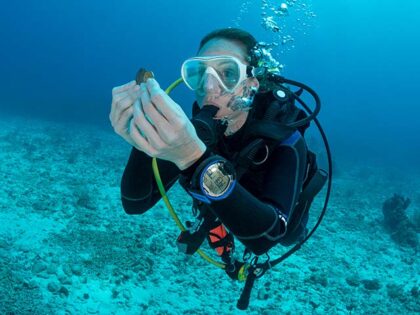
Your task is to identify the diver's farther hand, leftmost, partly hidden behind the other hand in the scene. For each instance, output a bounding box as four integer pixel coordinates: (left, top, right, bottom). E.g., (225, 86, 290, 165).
(109, 81, 140, 146)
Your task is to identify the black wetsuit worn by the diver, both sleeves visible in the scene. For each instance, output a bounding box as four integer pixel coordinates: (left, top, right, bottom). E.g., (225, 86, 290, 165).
(121, 97, 307, 255)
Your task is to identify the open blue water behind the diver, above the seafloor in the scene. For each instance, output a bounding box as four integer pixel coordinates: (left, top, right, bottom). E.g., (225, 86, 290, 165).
(0, 0, 420, 314)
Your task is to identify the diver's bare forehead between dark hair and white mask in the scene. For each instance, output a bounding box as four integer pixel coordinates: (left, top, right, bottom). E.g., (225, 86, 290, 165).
(198, 38, 245, 61)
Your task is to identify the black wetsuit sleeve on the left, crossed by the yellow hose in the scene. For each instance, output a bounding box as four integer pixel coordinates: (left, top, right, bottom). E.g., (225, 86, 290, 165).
(121, 148, 180, 214)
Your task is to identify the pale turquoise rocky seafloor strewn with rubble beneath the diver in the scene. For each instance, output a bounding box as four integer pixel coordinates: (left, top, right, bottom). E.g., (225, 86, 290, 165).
(0, 117, 420, 315)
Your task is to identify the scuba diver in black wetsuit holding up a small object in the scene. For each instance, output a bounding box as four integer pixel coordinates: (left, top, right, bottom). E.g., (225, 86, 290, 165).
(109, 28, 326, 309)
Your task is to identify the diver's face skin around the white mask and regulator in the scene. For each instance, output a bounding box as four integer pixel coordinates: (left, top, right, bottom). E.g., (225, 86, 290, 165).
(195, 39, 258, 120)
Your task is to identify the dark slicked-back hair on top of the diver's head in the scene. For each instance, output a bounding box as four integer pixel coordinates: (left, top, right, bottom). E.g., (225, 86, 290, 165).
(198, 28, 258, 66)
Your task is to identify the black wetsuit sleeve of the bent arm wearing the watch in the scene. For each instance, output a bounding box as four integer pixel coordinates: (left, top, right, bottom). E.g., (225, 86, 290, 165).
(179, 133, 306, 255)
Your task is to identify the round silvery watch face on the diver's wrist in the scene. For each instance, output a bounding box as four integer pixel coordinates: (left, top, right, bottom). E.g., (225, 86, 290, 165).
(203, 162, 233, 197)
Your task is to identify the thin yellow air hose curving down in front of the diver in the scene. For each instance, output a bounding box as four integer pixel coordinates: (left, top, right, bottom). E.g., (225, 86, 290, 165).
(152, 78, 225, 269)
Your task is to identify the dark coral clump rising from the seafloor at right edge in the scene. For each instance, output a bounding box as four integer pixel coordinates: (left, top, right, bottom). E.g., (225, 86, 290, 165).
(382, 194, 418, 248)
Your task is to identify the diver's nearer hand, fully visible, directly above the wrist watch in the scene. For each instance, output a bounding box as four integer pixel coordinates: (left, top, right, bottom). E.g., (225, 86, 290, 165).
(129, 79, 206, 170)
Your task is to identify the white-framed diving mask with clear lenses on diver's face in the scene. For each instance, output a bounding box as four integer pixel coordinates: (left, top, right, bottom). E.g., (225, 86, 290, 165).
(181, 55, 253, 93)
